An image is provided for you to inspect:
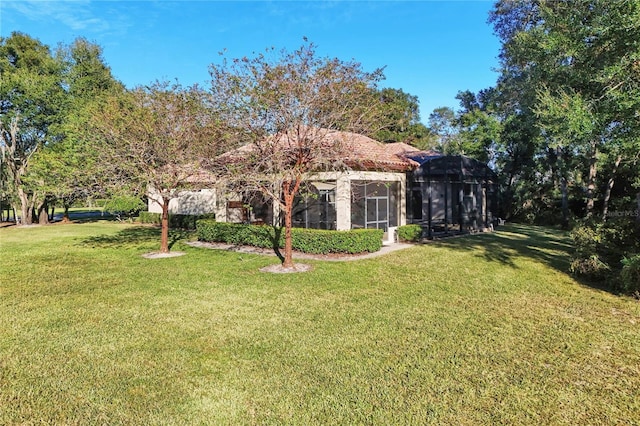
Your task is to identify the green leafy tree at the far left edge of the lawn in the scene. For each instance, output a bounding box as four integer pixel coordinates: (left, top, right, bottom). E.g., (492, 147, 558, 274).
(0, 32, 64, 224)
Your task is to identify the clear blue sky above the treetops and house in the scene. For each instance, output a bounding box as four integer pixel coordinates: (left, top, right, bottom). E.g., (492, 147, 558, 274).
(0, 0, 500, 123)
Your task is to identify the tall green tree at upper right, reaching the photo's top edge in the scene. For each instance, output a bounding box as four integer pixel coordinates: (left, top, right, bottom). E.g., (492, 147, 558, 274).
(490, 0, 640, 220)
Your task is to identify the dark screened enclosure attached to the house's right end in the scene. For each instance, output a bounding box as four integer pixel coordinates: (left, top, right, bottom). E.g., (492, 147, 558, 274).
(407, 152, 498, 238)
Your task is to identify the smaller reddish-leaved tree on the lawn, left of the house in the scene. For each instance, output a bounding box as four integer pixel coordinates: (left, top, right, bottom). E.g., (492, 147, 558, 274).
(89, 82, 227, 253)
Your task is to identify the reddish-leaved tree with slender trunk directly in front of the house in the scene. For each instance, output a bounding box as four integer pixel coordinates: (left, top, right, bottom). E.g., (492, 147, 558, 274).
(210, 40, 383, 268)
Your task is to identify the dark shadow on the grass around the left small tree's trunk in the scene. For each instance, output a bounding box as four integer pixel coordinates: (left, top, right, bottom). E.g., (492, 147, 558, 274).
(82, 226, 193, 249)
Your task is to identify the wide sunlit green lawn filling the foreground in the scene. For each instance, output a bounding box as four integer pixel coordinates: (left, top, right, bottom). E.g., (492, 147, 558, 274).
(0, 222, 640, 425)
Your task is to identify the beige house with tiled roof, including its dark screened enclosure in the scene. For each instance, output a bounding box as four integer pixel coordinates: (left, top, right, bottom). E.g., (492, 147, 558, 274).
(149, 130, 496, 242)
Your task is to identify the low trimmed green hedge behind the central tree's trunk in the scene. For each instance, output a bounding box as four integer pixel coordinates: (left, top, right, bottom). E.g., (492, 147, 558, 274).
(196, 220, 383, 254)
